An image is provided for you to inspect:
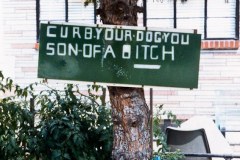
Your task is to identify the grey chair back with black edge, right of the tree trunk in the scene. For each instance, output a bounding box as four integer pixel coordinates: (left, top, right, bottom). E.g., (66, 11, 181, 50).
(166, 127, 212, 160)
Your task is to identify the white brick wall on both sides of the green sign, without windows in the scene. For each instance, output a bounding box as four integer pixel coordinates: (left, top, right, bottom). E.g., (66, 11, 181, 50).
(0, 0, 240, 151)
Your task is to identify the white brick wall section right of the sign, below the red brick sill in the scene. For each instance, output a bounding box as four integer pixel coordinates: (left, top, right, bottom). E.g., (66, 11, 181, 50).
(156, 50, 240, 117)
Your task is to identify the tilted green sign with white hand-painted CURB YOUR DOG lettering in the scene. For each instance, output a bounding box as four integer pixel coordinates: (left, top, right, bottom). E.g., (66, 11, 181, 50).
(38, 24, 201, 88)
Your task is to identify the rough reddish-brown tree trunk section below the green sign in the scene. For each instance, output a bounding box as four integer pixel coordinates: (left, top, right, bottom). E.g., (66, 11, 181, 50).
(108, 87, 151, 160)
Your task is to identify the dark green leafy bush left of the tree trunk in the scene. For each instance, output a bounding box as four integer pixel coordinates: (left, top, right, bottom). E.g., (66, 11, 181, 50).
(0, 72, 112, 160)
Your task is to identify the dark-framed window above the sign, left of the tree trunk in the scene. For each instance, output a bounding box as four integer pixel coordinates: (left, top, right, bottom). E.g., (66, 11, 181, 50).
(36, 0, 96, 41)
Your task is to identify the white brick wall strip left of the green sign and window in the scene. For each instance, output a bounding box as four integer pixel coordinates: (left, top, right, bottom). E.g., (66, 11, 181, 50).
(2, 0, 38, 85)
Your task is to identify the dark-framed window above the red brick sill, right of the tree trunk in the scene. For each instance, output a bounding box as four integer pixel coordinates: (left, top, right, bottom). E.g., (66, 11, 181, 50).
(146, 0, 239, 40)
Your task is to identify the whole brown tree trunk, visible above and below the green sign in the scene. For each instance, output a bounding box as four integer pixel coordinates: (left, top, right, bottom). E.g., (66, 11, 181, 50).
(97, 0, 151, 160)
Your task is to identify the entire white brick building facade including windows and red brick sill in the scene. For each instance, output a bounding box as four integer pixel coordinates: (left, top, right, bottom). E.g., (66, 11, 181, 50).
(0, 0, 240, 151)
